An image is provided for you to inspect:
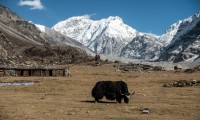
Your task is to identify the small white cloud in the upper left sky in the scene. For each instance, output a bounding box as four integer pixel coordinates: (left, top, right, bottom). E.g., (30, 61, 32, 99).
(18, 0, 44, 10)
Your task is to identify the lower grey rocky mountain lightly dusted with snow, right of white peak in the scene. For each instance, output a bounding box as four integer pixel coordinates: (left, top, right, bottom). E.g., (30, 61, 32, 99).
(120, 33, 163, 60)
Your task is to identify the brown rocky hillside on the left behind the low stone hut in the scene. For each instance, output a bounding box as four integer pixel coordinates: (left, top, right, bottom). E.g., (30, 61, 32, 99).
(0, 5, 94, 66)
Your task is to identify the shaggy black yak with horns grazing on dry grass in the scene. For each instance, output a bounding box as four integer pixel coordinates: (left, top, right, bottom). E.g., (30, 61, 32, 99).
(92, 81, 134, 103)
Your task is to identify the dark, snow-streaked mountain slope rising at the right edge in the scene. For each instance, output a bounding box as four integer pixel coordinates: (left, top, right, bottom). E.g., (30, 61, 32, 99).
(159, 12, 200, 62)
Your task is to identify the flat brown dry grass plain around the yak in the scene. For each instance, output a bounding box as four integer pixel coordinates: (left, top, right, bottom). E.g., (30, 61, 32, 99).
(0, 64, 200, 120)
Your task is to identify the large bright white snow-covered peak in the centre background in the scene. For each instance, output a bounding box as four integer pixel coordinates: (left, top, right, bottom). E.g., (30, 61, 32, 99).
(52, 16, 138, 56)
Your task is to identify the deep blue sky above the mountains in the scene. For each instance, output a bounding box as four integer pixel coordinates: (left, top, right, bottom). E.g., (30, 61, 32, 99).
(0, 0, 200, 35)
